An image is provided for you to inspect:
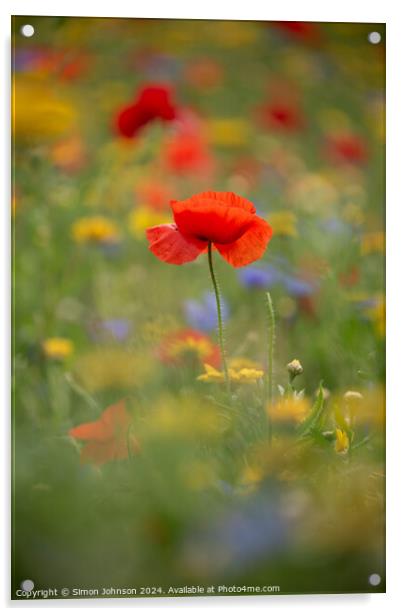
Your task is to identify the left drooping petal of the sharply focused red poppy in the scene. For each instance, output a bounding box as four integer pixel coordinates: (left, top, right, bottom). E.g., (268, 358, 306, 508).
(146, 224, 208, 265)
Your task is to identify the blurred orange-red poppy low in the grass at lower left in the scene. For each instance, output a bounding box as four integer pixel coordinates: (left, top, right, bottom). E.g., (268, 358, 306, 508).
(69, 400, 139, 465)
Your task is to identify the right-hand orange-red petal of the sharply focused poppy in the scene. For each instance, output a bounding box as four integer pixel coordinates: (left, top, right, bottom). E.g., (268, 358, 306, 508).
(214, 216, 272, 267)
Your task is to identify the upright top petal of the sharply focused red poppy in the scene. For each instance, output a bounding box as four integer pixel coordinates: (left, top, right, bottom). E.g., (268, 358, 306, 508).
(171, 198, 254, 244)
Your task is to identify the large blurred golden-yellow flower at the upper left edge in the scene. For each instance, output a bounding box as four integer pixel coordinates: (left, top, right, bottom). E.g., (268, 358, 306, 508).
(13, 76, 76, 141)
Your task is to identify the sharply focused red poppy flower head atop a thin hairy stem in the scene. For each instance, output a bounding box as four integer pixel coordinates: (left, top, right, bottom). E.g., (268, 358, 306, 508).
(146, 190, 272, 267)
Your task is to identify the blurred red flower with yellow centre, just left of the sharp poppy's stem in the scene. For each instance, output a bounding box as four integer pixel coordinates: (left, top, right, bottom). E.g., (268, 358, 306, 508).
(158, 329, 221, 368)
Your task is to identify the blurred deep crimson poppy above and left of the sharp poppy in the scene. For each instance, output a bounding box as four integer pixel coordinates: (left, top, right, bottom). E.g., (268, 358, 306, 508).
(116, 84, 176, 139)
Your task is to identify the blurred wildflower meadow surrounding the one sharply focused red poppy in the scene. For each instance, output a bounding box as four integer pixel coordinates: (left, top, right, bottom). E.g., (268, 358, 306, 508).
(12, 17, 385, 594)
